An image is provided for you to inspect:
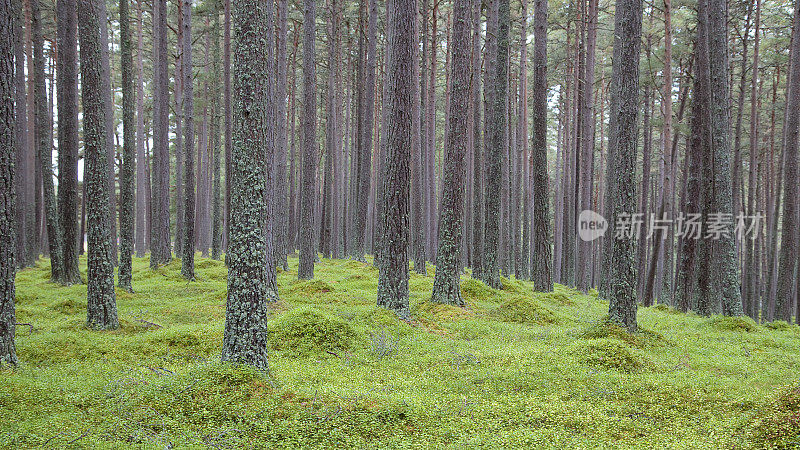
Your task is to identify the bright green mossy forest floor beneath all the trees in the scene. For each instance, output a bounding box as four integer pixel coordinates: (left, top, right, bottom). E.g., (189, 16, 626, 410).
(0, 258, 800, 449)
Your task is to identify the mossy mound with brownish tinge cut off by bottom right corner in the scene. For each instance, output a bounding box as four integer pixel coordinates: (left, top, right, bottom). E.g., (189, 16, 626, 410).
(744, 385, 800, 449)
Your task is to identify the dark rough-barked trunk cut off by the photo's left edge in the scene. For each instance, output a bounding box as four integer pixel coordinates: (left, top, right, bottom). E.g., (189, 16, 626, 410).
(0, 0, 19, 368)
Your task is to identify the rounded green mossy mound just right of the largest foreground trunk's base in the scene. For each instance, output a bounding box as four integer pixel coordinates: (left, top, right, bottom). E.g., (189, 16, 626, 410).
(269, 308, 357, 355)
